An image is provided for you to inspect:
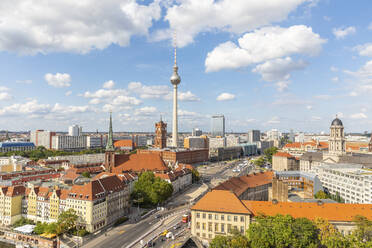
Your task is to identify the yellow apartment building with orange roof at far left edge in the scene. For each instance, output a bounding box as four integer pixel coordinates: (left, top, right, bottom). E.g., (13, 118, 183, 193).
(0, 186, 25, 225)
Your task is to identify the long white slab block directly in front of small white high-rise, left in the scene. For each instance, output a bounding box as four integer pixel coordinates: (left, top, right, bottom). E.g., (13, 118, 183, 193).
(52, 136, 87, 150)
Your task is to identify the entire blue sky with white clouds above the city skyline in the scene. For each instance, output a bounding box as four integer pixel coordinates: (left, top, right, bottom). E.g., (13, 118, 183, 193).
(0, 0, 372, 132)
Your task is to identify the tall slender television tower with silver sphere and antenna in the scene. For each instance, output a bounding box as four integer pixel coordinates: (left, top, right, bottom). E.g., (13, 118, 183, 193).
(170, 36, 181, 147)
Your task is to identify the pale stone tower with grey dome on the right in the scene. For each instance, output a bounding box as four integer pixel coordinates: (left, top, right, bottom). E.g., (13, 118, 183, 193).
(328, 116, 346, 155)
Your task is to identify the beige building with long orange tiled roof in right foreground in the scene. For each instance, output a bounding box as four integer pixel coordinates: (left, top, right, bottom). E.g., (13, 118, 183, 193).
(191, 190, 372, 242)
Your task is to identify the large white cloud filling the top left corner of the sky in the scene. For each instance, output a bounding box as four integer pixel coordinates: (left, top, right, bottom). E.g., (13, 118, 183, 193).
(0, 0, 161, 54)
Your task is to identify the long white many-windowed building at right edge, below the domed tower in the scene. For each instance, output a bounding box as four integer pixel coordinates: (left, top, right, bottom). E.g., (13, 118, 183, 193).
(317, 164, 372, 204)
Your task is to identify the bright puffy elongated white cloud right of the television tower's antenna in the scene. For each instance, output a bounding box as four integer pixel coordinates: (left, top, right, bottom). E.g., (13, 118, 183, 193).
(205, 25, 326, 72)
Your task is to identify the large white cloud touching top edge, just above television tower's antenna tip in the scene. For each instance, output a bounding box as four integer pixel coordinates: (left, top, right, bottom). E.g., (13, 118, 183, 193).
(161, 0, 306, 47)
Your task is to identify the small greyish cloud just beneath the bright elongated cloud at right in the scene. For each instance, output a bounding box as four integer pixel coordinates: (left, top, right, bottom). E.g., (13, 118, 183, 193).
(252, 57, 307, 82)
